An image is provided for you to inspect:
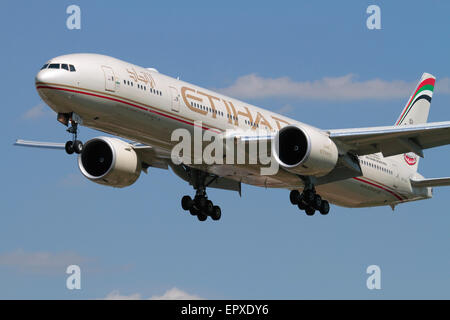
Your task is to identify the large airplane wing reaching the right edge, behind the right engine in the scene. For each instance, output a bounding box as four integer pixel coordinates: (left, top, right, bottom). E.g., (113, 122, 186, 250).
(328, 121, 450, 157)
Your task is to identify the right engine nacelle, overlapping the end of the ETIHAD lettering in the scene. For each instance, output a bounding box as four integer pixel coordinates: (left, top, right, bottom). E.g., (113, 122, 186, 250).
(272, 125, 339, 176)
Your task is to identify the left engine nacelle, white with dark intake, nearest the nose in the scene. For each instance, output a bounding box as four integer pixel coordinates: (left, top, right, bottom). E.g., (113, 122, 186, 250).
(78, 137, 142, 188)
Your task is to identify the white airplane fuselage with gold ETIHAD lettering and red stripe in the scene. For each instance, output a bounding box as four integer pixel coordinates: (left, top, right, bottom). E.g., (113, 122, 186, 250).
(36, 54, 431, 207)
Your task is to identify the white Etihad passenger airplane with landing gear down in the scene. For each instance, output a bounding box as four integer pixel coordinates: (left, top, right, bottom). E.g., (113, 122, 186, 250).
(15, 53, 450, 221)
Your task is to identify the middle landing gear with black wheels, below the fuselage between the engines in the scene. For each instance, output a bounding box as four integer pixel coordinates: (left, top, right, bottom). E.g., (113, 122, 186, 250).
(181, 169, 222, 221)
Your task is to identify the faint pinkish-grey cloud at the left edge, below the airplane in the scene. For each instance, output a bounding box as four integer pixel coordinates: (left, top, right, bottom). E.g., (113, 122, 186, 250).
(0, 249, 87, 273)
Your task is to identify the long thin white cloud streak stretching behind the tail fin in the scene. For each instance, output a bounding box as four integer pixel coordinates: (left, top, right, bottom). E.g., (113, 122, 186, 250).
(219, 74, 450, 100)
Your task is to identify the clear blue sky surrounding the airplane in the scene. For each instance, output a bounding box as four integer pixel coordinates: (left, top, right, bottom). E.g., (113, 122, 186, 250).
(0, 1, 450, 299)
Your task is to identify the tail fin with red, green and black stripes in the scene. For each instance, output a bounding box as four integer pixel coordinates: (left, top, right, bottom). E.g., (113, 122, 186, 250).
(393, 73, 436, 171)
